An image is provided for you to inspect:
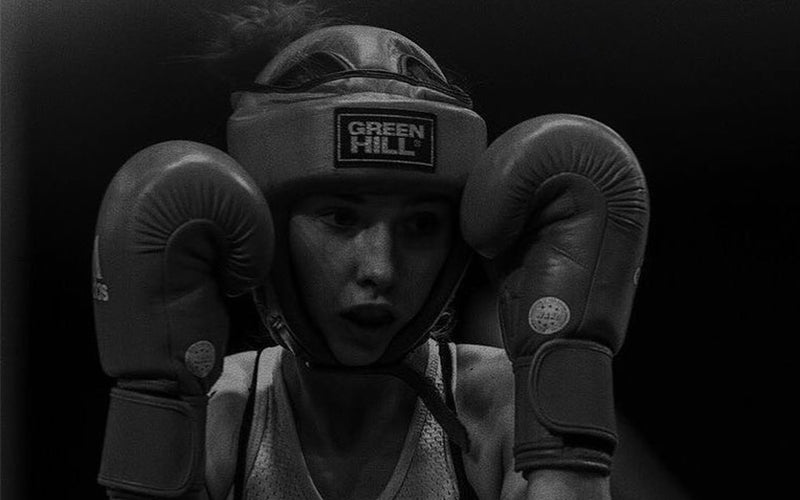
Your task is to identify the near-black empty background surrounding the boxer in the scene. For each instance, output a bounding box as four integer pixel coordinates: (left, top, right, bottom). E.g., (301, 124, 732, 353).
(0, 0, 800, 499)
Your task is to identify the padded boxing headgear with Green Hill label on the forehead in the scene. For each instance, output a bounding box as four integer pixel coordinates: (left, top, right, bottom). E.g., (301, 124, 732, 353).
(228, 26, 486, 365)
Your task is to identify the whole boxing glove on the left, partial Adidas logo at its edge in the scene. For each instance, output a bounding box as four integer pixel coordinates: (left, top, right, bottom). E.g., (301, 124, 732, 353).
(93, 141, 273, 498)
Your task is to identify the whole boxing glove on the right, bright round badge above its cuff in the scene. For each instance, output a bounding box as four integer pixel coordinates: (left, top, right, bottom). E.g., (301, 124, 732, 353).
(461, 115, 649, 475)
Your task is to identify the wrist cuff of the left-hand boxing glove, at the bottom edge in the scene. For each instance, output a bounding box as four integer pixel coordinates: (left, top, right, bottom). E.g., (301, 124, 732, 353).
(97, 388, 208, 498)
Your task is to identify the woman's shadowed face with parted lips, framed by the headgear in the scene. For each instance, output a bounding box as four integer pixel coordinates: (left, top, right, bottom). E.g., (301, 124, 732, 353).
(289, 194, 454, 366)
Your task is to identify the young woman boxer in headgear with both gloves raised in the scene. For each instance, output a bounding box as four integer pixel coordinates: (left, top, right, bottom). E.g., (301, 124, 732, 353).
(95, 17, 648, 499)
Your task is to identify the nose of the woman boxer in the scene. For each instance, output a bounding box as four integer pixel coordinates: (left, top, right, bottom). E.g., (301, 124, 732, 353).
(356, 223, 397, 291)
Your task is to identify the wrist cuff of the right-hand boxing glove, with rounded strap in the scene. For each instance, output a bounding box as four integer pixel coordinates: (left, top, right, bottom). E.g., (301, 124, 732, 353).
(514, 339, 617, 475)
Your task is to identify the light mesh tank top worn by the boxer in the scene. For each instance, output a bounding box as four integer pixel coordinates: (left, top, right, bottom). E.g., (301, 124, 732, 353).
(244, 340, 459, 500)
